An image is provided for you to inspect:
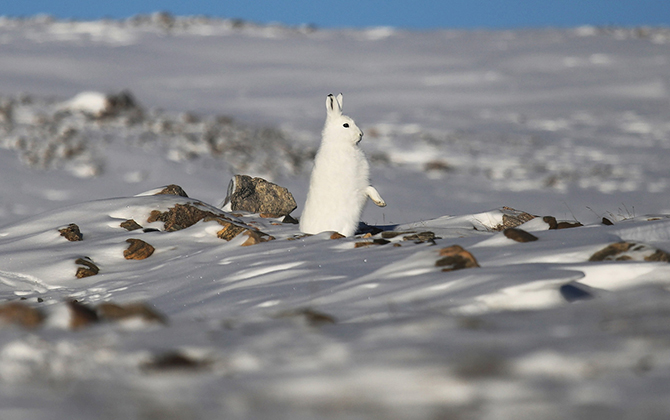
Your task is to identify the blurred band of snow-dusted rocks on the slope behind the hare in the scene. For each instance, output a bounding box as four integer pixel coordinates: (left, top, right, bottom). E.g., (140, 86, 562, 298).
(0, 91, 314, 177)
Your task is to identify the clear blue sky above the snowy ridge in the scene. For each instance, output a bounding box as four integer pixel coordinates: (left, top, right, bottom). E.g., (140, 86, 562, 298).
(0, 0, 670, 29)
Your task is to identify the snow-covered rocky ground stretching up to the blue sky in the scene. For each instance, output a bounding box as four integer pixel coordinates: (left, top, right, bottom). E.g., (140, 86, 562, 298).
(0, 15, 670, 419)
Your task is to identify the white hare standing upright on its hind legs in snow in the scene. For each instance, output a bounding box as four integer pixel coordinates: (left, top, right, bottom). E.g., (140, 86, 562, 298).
(300, 93, 386, 236)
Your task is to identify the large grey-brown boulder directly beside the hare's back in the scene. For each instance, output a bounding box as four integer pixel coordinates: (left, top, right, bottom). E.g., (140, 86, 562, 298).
(224, 175, 298, 218)
